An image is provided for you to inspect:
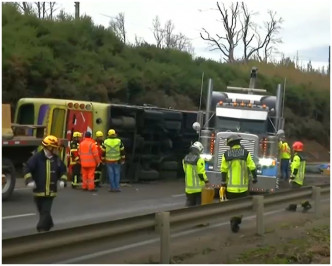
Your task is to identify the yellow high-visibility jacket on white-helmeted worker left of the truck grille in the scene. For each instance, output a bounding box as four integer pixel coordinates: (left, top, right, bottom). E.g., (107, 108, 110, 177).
(182, 153, 208, 194)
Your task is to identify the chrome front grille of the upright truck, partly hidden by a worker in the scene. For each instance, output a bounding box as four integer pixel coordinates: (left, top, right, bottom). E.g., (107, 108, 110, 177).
(214, 132, 259, 171)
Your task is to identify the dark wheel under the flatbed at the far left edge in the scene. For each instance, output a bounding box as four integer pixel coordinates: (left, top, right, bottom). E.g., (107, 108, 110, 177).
(2, 158, 16, 200)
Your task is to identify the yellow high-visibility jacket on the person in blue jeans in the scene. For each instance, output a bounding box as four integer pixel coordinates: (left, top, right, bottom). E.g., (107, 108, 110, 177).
(102, 137, 125, 163)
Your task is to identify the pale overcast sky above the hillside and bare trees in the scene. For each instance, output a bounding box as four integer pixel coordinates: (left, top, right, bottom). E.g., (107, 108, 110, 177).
(58, 0, 331, 68)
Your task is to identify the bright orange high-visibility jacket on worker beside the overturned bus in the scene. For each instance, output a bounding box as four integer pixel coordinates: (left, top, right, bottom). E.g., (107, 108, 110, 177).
(78, 138, 100, 167)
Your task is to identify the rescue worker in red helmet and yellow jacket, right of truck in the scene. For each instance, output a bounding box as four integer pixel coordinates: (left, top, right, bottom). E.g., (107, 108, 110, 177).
(289, 141, 306, 188)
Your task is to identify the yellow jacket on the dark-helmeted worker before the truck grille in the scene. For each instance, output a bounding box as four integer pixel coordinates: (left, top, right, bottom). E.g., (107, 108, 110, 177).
(221, 145, 256, 193)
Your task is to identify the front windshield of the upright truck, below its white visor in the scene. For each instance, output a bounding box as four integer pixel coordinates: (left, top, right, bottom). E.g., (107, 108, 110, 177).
(216, 116, 267, 134)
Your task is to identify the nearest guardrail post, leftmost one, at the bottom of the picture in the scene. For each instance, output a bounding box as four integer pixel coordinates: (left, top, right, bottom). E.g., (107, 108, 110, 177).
(156, 212, 171, 264)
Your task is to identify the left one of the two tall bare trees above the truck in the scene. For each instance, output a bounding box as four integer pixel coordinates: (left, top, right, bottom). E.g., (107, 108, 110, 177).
(200, 2, 242, 63)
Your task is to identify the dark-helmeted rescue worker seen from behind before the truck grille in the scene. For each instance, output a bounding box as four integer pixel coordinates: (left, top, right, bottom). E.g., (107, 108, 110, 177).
(220, 134, 257, 233)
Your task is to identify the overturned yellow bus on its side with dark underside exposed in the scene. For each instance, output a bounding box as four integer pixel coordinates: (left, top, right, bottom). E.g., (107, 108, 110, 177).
(15, 98, 198, 182)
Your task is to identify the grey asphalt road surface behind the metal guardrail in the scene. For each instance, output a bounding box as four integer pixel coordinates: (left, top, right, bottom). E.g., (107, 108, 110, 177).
(2, 174, 330, 239)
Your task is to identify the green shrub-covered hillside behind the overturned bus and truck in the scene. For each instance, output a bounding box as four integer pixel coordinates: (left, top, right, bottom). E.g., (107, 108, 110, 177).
(2, 2, 330, 146)
